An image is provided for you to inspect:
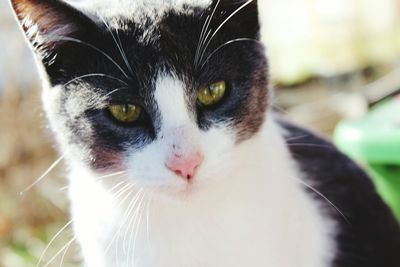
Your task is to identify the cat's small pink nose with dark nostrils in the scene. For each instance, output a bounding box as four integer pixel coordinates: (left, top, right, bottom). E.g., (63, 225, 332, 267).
(165, 153, 203, 180)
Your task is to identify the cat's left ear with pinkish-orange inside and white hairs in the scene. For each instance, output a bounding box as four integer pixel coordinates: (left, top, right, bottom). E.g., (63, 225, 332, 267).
(11, 0, 94, 65)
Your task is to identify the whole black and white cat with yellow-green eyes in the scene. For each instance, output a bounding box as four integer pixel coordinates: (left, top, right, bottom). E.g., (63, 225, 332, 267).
(11, 0, 400, 267)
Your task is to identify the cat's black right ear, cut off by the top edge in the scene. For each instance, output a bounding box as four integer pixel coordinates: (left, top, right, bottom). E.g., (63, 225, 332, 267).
(214, 0, 260, 39)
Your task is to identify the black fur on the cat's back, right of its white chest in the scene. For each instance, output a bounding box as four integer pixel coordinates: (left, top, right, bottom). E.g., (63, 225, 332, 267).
(281, 122, 400, 267)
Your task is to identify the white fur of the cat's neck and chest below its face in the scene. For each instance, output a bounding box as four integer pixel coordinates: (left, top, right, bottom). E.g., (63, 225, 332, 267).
(70, 121, 335, 267)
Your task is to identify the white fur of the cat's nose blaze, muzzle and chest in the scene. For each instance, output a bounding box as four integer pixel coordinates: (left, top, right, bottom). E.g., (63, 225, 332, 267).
(63, 77, 335, 267)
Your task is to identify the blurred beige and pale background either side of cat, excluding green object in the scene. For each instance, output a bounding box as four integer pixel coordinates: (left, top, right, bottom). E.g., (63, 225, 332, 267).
(0, 0, 400, 267)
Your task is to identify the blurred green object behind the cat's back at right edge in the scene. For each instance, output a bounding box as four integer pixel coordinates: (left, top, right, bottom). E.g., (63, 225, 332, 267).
(333, 95, 400, 221)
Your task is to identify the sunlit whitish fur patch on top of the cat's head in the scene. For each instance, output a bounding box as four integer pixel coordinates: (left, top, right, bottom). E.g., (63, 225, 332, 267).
(69, 0, 215, 44)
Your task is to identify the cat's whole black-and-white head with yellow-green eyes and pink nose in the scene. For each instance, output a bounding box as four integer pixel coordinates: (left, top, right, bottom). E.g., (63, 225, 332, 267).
(12, 0, 268, 194)
